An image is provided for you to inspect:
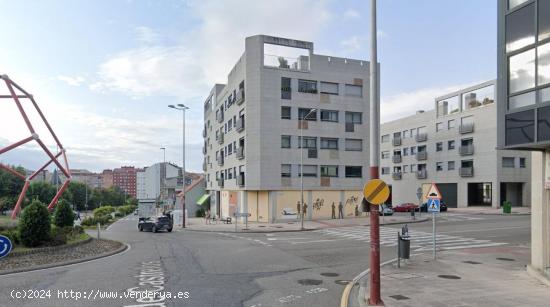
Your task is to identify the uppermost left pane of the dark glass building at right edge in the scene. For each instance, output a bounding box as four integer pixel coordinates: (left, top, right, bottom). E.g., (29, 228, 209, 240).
(506, 1, 544, 52)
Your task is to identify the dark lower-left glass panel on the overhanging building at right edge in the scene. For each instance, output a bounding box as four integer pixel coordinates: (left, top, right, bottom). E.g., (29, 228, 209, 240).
(505, 110, 535, 145)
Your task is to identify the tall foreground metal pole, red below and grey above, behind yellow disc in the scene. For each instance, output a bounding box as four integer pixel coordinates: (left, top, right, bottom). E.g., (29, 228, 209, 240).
(368, 0, 384, 305)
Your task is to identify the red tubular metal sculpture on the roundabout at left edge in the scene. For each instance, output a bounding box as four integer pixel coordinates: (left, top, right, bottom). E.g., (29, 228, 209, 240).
(0, 75, 71, 219)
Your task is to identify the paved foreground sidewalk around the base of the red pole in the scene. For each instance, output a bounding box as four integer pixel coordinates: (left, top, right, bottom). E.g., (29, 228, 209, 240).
(349, 247, 550, 307)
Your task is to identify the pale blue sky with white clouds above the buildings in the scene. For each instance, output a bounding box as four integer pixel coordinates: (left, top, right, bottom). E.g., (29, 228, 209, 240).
(0, 0, 497, 172)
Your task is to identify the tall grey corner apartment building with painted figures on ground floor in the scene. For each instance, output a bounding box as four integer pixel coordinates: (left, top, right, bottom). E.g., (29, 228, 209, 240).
(203, 35, 376, 222)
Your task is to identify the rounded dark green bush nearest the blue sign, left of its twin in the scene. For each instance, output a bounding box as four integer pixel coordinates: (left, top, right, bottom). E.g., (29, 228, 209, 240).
(18, 200, 51, 247)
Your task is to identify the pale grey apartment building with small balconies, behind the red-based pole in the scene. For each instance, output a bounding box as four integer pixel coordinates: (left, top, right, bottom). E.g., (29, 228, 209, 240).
(380, 81, 531, 208)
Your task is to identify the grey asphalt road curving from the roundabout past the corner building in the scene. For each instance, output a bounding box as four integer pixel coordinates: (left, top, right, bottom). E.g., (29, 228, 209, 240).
(0, 214, 530, 306)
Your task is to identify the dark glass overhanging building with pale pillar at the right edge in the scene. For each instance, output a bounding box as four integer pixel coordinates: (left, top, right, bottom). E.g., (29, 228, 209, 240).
(497, 0, 550, 279)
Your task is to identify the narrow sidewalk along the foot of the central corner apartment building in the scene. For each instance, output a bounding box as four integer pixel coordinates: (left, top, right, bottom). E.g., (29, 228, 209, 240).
(183, 215, 428, 232)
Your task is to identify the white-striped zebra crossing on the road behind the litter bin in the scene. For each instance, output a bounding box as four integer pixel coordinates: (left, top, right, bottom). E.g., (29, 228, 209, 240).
(314, 226, 507, 252)
